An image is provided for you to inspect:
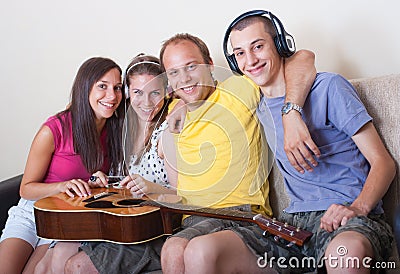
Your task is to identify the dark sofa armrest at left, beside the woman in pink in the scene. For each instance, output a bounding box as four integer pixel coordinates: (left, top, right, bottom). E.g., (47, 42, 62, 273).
(0, 174, 22, 231)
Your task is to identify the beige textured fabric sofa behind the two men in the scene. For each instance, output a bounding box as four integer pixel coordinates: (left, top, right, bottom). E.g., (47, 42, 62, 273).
(269, 74, 400, 273)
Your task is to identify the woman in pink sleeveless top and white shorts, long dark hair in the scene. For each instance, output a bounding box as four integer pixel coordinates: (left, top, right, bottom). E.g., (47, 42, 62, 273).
(0, 57, 124, 273)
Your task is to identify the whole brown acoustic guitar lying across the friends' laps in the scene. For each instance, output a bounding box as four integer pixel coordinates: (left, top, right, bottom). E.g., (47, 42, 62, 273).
(34, 188, 312, 246)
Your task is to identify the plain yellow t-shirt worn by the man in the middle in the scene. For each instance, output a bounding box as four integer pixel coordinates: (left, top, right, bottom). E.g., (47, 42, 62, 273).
(175, 76, 272, 215)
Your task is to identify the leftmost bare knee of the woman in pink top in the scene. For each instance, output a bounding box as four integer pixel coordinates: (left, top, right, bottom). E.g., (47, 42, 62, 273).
(0, 238, 33, 273)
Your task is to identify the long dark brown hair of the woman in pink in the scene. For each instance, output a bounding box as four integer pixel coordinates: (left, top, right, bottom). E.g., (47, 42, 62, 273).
(57, 57, 125, 173)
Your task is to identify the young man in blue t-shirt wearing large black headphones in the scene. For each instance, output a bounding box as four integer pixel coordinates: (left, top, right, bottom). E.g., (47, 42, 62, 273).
(224, 11, 395, 273)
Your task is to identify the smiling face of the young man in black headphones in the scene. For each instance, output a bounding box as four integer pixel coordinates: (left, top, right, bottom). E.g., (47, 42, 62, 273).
(230, 21, 282, 88)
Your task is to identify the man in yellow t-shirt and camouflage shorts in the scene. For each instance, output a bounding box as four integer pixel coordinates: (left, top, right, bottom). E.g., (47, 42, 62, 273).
(160, 34, 272, 273)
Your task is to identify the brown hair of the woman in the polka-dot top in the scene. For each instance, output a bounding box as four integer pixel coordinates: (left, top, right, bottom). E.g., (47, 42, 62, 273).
(125, 53, 170, 165)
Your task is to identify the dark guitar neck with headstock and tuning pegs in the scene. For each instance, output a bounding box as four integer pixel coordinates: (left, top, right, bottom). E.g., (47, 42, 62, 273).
(142, 201, 312, 246)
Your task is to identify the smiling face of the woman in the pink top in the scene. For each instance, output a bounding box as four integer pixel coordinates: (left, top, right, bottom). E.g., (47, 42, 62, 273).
(89, 68, 122, 122)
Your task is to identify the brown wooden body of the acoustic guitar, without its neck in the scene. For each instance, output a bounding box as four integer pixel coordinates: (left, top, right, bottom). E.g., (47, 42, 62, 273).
(34, 188, 182, 244)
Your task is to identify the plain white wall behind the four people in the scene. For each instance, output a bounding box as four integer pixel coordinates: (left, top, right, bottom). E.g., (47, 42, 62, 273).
(0, 0, 400, 180)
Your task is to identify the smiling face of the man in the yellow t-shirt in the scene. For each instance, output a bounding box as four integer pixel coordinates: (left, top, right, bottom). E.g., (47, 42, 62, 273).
(163, 40, 215, 111)
